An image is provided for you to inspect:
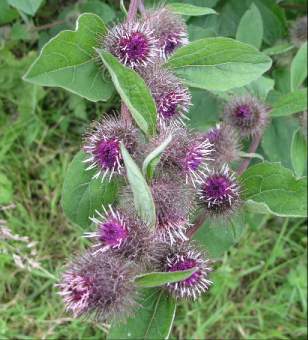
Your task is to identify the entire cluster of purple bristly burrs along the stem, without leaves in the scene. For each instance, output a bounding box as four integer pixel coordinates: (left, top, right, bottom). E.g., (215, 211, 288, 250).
(59, 7, 267, 319)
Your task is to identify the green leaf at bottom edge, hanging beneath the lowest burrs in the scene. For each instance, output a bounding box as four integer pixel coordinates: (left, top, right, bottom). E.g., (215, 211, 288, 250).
(107, 288, 176, 339)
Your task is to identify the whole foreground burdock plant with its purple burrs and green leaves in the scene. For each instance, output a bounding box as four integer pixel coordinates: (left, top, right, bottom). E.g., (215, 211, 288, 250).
(25, 0, 305, 339)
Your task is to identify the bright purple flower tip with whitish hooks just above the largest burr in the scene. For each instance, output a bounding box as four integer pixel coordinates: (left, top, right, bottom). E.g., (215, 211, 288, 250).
(86, 206, 129, 251)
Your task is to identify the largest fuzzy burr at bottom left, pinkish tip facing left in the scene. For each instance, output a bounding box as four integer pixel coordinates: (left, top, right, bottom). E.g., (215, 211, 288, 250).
(58, 252, 137, 320)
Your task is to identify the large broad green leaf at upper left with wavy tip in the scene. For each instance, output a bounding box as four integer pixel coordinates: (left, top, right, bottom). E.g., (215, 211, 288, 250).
(24, 13, 113, 102)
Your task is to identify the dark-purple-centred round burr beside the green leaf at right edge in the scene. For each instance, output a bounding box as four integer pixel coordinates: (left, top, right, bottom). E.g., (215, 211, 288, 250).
(198, 164, 241, 217)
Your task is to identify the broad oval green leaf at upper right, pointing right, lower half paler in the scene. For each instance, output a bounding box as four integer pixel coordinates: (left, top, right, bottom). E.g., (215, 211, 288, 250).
(166, 38, 272, 91)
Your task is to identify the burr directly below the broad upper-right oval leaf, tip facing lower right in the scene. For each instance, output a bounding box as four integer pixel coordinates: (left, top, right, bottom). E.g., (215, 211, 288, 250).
(140, 64, 191, 127)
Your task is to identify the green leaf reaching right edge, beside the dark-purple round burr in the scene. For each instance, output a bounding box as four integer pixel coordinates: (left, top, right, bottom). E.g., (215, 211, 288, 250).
(241, 162, 307, 217)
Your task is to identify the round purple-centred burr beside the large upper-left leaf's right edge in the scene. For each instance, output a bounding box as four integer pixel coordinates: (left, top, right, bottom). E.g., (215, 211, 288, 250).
(104, 22, 159, 68)
